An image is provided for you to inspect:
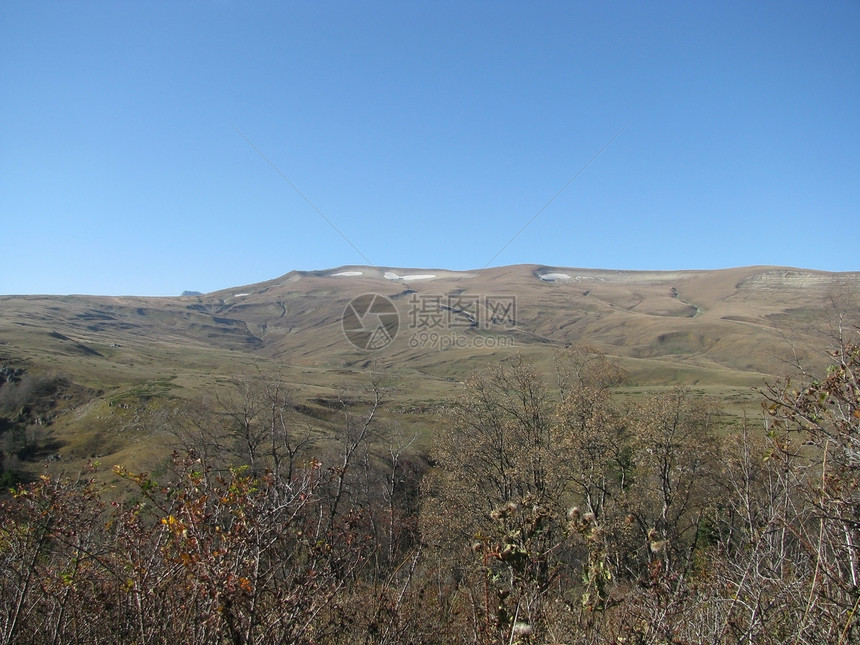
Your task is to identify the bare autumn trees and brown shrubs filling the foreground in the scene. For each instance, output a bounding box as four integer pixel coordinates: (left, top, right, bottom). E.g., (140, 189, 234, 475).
(0, 334, 860, 644)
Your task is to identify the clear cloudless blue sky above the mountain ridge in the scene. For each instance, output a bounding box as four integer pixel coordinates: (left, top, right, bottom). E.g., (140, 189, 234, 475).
(0, 0, 860, 295)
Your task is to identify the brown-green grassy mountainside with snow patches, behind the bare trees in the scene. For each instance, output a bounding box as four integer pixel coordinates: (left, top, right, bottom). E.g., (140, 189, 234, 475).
(0, 265, 860, 476)
